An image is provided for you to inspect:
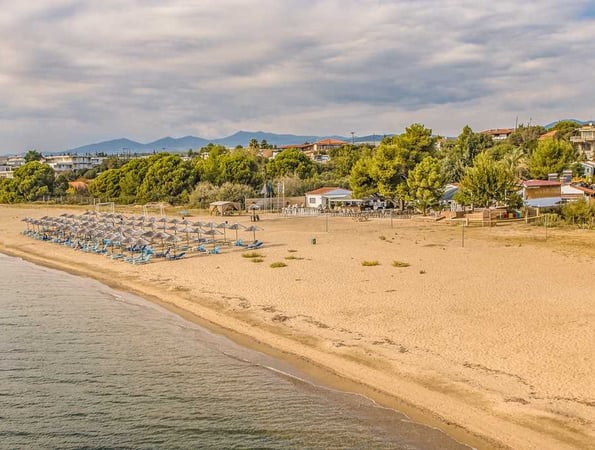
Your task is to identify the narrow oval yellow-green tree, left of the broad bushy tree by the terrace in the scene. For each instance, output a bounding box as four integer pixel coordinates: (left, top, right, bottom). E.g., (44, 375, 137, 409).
(407, 156, 445, 216)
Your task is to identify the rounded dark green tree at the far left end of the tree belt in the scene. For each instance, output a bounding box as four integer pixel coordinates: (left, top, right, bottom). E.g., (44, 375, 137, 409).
(13, 161, 55, 202)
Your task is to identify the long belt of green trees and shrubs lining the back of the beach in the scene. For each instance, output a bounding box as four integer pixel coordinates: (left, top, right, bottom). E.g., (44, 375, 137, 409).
(0, 121, 593, 224)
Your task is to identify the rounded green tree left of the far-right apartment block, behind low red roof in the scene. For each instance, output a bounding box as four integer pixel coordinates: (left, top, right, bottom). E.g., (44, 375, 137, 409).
(529, 139, 578, 179)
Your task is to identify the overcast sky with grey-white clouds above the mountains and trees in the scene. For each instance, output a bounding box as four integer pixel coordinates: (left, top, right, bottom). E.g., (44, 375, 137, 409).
(0, 0, 595, 154)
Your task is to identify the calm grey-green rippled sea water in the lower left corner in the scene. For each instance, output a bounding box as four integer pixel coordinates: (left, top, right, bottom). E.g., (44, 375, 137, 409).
(0, 254, 469, 449)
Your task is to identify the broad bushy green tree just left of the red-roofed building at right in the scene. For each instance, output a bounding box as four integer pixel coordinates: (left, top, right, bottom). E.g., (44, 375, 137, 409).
(455, 153, 517, 207)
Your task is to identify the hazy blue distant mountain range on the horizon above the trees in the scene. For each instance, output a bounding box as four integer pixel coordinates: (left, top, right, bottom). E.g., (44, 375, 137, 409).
(53, 131, 392, 154)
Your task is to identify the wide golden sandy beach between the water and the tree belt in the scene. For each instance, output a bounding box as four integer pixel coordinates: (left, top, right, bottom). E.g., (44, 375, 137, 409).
(0, 206, 595, 449)
